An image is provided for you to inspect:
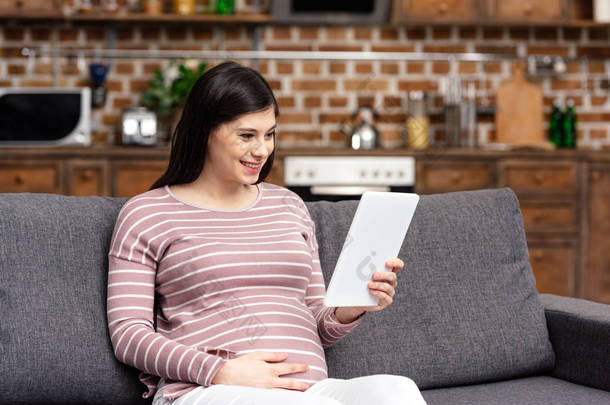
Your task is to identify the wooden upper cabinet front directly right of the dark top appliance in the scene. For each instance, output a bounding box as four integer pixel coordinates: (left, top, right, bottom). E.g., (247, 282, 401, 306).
(394, 0, 484, 23)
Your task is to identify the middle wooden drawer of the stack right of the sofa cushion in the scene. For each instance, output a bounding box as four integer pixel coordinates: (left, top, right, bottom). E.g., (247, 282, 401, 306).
(520, 201, 577, 231)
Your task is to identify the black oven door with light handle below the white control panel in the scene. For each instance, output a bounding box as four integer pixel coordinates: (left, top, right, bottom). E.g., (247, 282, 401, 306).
(286, 186, 413, 202)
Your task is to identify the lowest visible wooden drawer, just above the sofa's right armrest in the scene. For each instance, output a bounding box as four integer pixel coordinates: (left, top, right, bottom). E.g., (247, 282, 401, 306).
(528, 241, 576, 297)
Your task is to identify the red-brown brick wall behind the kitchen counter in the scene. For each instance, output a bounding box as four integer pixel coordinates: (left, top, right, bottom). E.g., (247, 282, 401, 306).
(0, 22, 610, 149)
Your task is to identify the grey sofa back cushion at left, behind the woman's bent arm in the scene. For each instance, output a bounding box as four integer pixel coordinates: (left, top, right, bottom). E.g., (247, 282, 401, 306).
(0, 194, 145, 404)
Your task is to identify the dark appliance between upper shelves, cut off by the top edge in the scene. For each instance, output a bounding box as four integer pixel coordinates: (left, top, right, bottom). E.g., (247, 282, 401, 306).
(271, 0, 392, 24)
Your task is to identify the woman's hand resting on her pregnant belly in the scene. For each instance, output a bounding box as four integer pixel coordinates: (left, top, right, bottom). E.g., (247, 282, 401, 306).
(212, 351, 309, 391)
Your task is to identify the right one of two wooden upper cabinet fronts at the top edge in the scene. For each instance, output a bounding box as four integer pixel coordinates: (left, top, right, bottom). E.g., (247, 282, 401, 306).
(494, 0, 567, 20)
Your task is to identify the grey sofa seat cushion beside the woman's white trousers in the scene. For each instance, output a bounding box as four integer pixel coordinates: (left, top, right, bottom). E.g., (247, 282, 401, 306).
(422, 376, 610, 405)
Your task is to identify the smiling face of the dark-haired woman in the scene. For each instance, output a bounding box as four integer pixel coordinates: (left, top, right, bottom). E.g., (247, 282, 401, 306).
(204, 107, 276, 184)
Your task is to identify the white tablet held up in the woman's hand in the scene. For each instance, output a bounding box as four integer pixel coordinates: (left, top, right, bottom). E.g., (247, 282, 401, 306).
(324, 191, 419, 307)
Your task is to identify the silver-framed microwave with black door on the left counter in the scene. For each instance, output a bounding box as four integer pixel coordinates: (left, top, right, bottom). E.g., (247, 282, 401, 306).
(0, 87, 91, 147)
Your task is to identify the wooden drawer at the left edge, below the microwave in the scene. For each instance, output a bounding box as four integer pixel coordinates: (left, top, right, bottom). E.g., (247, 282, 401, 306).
(0, 163, 62, 193)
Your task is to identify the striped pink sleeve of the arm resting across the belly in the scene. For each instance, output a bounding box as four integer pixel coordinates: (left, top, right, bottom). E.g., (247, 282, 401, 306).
(106, 200, 226, 398)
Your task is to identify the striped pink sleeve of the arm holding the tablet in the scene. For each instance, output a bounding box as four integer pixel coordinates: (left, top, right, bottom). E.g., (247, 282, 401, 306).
(302, 197, 366, 348)
